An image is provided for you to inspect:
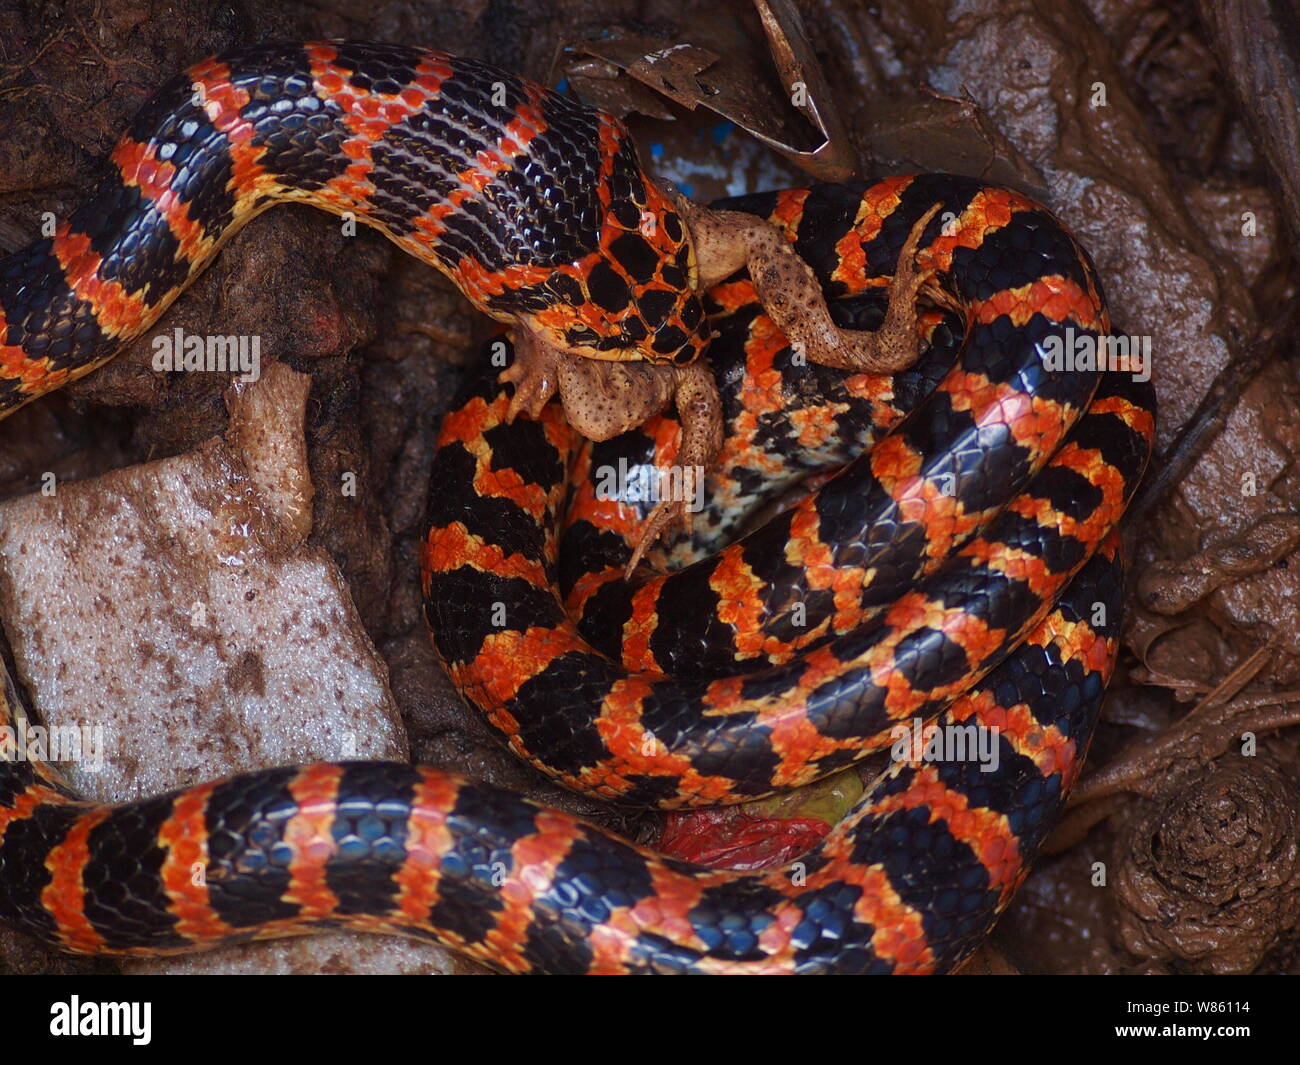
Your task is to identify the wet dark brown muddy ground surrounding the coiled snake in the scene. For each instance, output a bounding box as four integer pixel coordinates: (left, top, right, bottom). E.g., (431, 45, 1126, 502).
(0, 0, 1300, 973)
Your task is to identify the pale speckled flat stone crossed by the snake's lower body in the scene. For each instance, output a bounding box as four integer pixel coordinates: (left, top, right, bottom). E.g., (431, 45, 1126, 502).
(0, 364, 459, 973)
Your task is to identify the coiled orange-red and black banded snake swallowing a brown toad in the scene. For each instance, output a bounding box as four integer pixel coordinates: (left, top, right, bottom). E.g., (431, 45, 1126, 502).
(0, 42, 1153, 973)
